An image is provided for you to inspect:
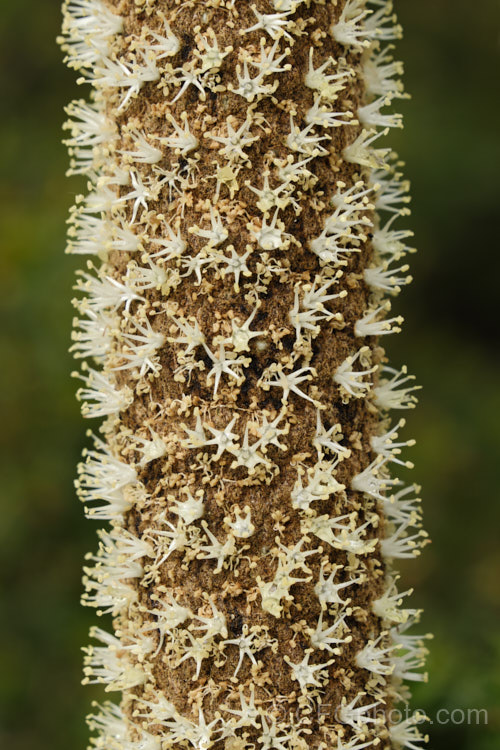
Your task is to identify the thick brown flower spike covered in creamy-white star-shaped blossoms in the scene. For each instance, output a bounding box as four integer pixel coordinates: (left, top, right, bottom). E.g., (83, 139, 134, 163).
(61, 0, 427, 750)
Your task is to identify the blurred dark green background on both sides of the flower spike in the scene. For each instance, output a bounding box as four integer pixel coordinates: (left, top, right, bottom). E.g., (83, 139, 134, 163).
(0, 0, 500, 750)
